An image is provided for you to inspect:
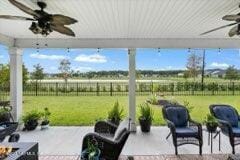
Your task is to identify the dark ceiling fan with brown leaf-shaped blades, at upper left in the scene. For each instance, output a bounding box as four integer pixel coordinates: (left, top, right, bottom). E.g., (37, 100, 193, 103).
(0, 0, 78, 37)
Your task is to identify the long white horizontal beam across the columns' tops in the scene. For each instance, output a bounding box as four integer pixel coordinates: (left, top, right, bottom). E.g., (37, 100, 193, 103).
(15, 38, 240, 48)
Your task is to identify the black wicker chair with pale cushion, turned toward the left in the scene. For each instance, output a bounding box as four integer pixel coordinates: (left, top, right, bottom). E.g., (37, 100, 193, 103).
(82, 119, 130, 160)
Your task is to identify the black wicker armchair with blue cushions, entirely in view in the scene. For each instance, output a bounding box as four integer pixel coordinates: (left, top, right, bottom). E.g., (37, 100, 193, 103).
(162, 105, 203, 155)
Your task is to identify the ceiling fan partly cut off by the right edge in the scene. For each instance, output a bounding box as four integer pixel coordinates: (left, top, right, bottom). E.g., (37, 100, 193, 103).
(200, 6, 240, 37)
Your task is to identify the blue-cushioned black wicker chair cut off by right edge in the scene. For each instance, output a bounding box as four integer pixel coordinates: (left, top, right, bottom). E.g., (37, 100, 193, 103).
(209, 104, 240, 154)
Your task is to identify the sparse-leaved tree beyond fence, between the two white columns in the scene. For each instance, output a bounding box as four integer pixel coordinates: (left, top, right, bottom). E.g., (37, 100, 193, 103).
(58, 59, 71, 83)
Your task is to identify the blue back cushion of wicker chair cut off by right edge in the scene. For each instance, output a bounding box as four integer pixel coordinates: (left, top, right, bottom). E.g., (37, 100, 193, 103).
(213, 106, 238, 127)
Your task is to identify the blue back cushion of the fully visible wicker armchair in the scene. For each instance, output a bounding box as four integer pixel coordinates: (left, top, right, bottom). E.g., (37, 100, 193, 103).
(166, 107, 188, 127)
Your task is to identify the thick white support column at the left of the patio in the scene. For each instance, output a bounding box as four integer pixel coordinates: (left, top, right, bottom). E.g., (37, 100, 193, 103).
(9, 47, 23, 121)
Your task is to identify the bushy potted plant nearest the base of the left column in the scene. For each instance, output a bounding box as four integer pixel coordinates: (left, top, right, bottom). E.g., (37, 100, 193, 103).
(22, 110, 41, 131)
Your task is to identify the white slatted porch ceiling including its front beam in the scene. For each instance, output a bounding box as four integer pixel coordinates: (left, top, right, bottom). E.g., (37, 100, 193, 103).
(0, 0, 240, 48)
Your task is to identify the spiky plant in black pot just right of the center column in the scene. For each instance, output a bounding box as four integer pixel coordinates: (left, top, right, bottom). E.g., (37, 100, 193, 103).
(139, 103, 153, 132)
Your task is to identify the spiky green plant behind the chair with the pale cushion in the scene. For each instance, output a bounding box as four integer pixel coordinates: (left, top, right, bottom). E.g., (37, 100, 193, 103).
(108, 101, 123, 125)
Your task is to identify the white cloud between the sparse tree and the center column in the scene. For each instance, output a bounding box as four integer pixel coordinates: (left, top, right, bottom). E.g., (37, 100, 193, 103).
(74, 54, 107, 63)
